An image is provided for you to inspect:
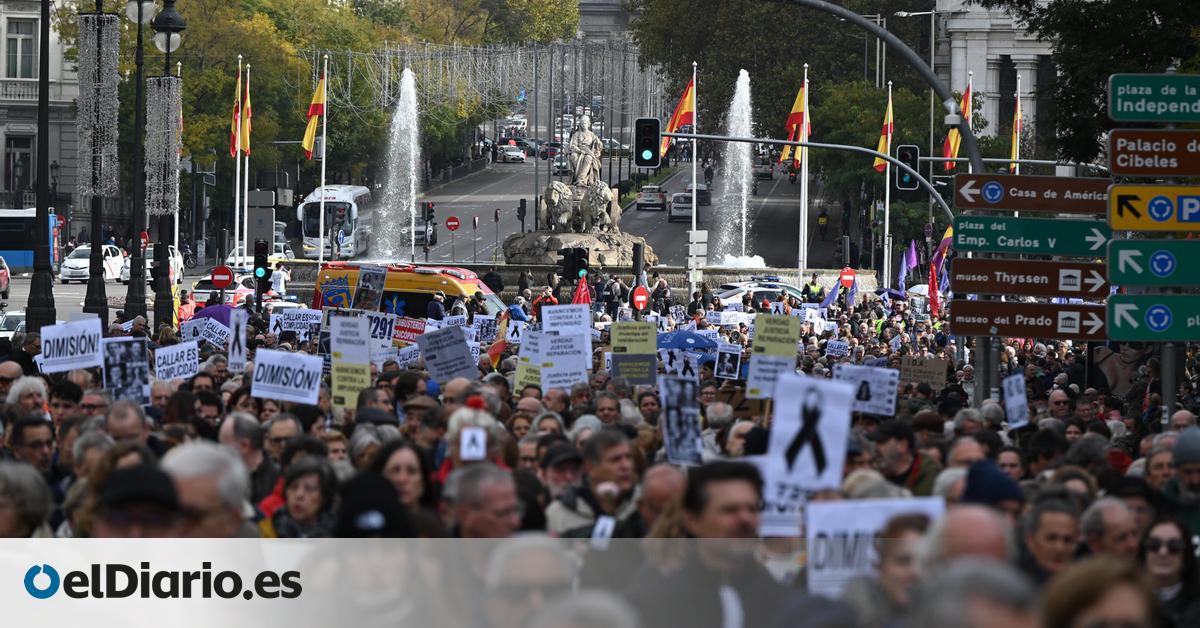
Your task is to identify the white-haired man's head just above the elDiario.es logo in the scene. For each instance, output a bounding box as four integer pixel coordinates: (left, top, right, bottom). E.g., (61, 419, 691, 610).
(162, 441, 258, 538)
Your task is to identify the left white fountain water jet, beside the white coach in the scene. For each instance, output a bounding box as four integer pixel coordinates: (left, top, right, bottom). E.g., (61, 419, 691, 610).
(384, 67, 428, 261)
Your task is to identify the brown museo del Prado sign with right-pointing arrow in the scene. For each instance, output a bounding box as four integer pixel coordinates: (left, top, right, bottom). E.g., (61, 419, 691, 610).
(950, 299, 1106, 340)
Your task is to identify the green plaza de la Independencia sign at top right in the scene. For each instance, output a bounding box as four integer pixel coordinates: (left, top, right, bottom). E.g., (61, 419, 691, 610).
(1109, 74, 1200, 122)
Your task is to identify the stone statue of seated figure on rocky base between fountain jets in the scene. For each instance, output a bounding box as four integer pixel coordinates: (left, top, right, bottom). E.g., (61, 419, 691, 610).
(538, 115, 620, 233)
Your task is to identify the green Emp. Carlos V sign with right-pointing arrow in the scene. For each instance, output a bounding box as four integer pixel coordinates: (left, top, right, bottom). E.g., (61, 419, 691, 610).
(954, 216, 1112, 257)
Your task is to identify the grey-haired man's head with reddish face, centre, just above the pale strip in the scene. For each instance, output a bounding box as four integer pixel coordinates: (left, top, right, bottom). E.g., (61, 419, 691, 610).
(443, 462, 522, 538)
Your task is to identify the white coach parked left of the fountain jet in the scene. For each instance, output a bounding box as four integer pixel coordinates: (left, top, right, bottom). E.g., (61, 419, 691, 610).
(296, 185, 372, 259)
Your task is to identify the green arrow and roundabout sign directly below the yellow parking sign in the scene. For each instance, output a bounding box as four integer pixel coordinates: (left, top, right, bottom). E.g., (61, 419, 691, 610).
(1108, 240, 1200, 287)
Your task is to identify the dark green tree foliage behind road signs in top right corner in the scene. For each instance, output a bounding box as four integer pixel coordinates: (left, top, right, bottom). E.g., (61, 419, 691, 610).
(978, 0, 1200, 162)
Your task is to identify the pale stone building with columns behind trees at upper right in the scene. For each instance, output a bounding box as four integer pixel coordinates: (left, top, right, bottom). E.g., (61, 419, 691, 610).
(935, 0, 1055, 139)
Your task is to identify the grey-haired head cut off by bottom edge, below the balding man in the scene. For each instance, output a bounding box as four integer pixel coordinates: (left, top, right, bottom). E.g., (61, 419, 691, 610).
(904, 558, 1039, 628)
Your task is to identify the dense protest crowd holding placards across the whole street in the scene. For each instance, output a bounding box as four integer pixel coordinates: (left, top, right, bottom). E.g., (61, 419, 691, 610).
(0, 268, 1200, 628)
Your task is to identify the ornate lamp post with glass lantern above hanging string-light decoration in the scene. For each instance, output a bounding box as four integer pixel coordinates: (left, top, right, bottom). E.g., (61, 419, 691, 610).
(145, 0, 187, 329)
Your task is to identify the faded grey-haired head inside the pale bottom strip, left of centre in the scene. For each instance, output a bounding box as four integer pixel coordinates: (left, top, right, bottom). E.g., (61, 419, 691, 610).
(484, 534, 575, 628)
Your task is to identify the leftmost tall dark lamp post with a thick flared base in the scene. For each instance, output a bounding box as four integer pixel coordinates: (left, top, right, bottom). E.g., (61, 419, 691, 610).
(26, 0, 56, 331)
